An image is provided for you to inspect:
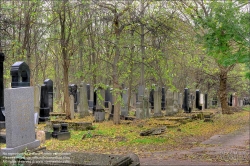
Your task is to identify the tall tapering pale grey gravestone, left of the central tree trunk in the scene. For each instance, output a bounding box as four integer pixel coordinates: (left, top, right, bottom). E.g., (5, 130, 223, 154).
(79, 82, 89, 118)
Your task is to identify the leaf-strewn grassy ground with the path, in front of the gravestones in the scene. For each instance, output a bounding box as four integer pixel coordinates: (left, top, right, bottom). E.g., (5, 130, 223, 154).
(0, 106, 250, 166)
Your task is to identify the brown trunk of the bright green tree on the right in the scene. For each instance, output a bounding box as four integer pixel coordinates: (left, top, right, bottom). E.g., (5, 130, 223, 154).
(219, 66, 232, 114)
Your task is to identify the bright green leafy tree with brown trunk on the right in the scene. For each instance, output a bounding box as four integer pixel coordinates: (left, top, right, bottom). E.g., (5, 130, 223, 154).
(188, 1, 249, 114)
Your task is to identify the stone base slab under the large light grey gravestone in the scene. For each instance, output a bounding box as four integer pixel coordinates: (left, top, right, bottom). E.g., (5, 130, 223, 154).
(1, 140, 40, 154)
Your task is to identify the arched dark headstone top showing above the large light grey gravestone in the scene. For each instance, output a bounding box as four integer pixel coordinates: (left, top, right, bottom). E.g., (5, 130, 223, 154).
(10, 61, 30, 88)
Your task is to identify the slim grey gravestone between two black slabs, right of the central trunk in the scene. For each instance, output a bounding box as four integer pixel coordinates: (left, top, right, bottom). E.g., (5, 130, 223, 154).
(154, 86, 162, 117)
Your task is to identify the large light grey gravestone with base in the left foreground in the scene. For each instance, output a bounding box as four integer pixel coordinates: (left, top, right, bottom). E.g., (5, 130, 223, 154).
(1, 87, 40, 153)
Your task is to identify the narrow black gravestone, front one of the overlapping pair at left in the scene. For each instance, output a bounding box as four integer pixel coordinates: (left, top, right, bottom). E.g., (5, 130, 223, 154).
(39, 84, 50, 122)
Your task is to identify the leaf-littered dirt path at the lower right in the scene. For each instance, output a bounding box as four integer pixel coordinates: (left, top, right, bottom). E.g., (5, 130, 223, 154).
(140, 126, 250, 166)
